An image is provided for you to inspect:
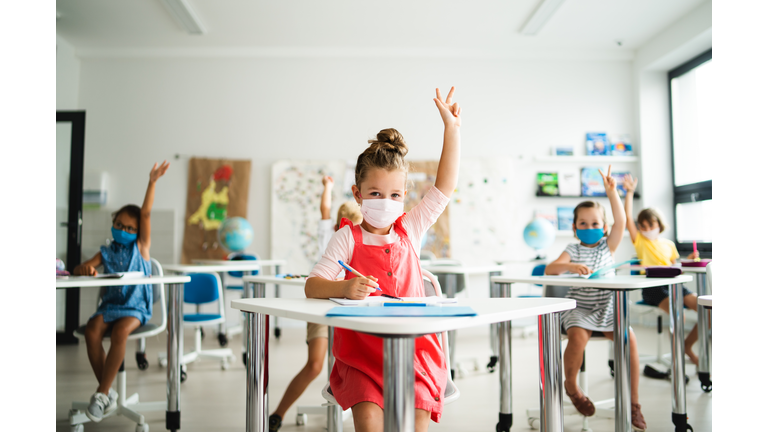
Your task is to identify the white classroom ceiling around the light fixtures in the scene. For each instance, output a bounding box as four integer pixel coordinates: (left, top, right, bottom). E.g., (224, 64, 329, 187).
(56, 0, 706, 52)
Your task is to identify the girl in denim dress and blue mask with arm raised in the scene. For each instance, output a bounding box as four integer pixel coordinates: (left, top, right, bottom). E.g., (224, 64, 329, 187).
(72, 161, 170, 423)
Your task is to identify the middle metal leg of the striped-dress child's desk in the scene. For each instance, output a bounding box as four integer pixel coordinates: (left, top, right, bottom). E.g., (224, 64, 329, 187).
(613, 290, 632, 432)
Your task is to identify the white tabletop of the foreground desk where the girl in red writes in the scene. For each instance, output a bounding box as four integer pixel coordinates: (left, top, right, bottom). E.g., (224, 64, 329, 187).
(231, 297, 576, 335)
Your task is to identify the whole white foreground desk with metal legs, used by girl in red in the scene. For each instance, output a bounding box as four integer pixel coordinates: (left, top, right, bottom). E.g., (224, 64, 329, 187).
(232, 298, 576, 432)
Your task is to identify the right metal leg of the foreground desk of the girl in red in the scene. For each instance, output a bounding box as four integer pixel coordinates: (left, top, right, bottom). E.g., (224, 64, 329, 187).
(539, 312, 563, 432)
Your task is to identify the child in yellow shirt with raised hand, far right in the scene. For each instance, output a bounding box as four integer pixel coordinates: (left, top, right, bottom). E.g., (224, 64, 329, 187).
(624, 175, 699, 366)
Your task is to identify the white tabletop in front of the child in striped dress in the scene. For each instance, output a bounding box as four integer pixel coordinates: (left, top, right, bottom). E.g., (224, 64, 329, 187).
(491, 275, 693, 290)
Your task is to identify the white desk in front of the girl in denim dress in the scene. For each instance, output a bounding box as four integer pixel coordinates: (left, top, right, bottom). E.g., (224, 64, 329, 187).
(56, 276, 191, 431)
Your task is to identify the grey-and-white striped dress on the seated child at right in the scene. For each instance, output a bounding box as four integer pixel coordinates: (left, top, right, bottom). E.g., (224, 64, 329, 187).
(560, 237, 616, 332)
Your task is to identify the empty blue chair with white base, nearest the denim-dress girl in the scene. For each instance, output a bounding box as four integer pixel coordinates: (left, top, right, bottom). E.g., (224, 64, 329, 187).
(158, 273, 235, 375)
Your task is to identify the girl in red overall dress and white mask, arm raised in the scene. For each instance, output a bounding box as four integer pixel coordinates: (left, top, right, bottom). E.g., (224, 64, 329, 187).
(305, 88, 461, 432)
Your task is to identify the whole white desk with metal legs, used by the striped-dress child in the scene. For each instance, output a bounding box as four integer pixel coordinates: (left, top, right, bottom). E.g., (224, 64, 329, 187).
(491, 275, 693, 432)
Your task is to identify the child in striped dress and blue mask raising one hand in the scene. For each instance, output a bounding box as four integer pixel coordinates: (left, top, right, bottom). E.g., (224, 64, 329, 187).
(544, 166, 646, 431)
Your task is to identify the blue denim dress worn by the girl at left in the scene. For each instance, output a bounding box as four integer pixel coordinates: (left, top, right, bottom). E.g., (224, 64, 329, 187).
(91, 241, 152, 325)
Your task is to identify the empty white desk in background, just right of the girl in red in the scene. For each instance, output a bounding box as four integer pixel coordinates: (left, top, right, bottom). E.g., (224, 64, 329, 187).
(421, 260, 506, 378)
